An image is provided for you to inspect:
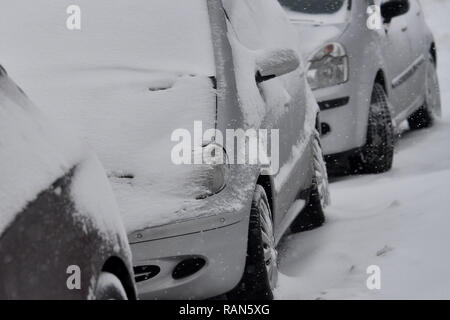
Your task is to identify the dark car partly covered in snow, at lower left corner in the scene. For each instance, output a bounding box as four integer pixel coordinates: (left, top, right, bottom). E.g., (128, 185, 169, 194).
(0, 67, 136, 300)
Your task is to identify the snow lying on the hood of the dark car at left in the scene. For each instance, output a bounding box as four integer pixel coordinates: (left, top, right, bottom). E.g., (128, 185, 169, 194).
(0, 75, 84, 234)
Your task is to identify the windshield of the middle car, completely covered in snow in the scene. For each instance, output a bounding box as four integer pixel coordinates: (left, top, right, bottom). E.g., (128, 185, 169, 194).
(0, 0, 215, 76)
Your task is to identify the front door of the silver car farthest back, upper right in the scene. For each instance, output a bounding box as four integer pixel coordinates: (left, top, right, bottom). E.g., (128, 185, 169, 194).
(383, 6, 412, 119)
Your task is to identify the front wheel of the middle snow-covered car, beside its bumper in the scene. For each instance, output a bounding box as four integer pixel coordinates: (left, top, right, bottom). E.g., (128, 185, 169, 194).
(228, 185, 278, 300)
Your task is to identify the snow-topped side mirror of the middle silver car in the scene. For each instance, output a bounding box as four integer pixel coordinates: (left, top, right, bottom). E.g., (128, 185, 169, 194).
(255, 49, 300, 83)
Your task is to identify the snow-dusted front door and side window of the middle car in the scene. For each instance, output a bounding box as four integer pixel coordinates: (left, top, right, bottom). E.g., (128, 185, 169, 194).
(223, 0, 310, 225)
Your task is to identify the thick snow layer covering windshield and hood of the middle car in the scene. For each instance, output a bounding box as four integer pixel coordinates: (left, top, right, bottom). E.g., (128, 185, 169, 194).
(0, 0, 216, 232)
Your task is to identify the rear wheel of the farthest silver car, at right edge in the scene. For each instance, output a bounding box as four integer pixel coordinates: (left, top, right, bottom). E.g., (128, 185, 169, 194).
(408, 55, 442, 130)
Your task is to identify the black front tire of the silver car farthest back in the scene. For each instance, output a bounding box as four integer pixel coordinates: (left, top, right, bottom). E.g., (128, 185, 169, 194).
(351, 83, 394, 174)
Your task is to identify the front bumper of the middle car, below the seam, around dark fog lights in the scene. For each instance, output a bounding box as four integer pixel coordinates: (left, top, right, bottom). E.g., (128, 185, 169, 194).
(131, 217, 248, 299)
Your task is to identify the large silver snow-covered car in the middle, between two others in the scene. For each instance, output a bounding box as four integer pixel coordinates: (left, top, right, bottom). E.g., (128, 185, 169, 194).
(0, 0, 328, 299)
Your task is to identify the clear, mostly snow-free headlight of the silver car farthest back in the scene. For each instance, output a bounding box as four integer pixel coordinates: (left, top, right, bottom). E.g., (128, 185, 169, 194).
(307, 43, 349, 90)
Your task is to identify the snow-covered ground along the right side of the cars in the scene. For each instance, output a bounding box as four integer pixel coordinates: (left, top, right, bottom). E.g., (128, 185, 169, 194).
(277, 0, 450, 299)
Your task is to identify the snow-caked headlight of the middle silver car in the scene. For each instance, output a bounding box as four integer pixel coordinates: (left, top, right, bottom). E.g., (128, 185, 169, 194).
(194, 143, 230, 199)
